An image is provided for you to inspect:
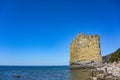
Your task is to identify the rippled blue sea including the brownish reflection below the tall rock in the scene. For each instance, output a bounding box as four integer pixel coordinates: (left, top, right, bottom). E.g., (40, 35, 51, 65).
(0, 66, 90, 80)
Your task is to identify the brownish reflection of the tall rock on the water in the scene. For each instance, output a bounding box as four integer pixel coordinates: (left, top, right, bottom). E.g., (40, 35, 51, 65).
(70, 70, 91, 80)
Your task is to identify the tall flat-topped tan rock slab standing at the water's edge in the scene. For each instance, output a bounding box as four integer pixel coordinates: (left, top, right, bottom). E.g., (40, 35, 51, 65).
(70, 33, 102, 69)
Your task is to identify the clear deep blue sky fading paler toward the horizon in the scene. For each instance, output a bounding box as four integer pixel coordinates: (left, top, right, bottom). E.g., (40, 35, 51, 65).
(0, 0, 120, 65)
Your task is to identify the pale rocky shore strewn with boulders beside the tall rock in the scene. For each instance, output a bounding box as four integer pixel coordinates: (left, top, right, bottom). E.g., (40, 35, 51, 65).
(90, 63, 120, 80)
